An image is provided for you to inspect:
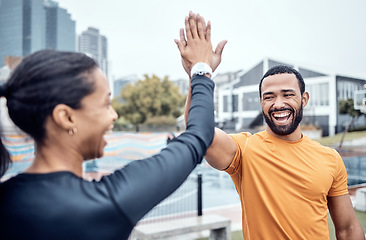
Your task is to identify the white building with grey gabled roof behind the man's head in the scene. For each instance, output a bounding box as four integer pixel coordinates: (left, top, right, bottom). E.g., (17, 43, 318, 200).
(214, 59, 366, 136)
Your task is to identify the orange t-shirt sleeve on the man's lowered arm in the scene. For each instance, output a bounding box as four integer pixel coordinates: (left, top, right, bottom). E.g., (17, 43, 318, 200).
(328, 150, 348, 197)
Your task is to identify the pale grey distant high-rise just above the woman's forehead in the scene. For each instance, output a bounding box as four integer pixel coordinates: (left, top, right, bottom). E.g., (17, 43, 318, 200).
(79, 27, 108, 76)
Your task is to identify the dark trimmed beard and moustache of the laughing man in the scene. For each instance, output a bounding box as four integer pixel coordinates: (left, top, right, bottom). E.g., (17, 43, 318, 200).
(262, 102, 303, 136)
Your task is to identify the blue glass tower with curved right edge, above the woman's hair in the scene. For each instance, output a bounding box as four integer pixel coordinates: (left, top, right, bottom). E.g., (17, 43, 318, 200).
(45, 1, 76, 51)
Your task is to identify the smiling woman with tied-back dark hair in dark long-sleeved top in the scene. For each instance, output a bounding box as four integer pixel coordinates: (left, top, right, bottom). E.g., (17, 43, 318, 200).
(0, 12, 214, 240)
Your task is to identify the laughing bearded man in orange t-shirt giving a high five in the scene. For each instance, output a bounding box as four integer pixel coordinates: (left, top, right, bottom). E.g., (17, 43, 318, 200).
(176, 14, 365, 240)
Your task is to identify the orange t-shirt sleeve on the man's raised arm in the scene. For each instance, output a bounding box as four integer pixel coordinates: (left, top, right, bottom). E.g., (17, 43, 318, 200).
(225, 133, 251, 175)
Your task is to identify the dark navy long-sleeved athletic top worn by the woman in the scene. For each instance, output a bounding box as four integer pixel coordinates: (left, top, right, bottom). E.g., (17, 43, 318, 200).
(0, 76, 214, 240)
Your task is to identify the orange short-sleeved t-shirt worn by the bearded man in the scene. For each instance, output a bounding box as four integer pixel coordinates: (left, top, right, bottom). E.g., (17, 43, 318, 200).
(225, 131, 348, 240)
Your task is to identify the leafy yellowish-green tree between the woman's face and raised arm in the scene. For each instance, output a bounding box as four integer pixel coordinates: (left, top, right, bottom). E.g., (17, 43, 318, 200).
(116, 75, 184, 131)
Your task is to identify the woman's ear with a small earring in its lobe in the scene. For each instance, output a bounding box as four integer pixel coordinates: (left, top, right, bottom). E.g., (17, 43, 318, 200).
(52, 104, 76, 131)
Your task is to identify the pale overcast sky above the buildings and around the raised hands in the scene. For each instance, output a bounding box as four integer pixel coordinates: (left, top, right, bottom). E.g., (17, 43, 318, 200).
(58, 0, 366, 79)
